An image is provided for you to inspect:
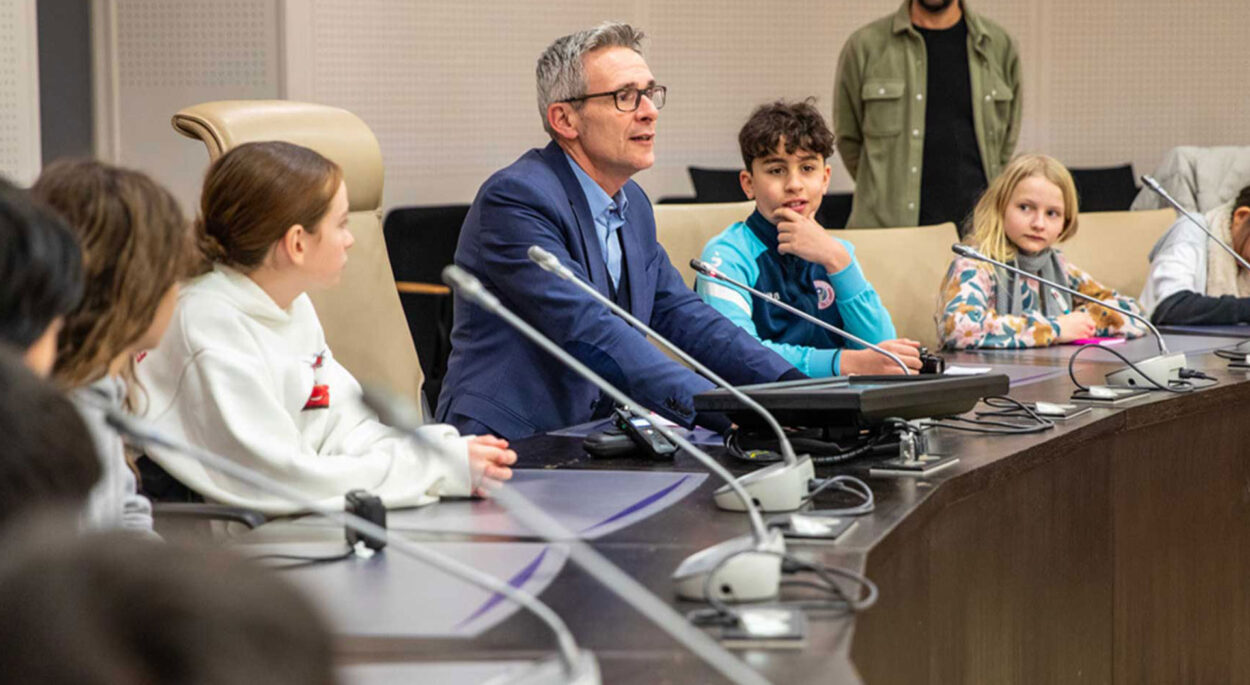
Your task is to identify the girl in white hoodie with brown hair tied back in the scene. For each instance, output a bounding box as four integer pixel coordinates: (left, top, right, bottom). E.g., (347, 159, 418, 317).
(138, 143, 516, 514)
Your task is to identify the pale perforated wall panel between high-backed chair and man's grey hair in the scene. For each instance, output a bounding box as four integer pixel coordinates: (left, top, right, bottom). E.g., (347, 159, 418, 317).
(306, 0, 634, 210)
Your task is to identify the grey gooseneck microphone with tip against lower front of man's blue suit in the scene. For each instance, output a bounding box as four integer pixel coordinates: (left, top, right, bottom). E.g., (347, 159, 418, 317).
(443, 265, 785, 601)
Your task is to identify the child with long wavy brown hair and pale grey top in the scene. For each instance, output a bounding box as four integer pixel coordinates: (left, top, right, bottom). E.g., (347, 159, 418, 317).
(31, 160, 195, 533)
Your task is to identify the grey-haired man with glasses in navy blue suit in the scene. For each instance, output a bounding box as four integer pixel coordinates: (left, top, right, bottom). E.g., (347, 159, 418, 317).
(438, 24, 805, 439)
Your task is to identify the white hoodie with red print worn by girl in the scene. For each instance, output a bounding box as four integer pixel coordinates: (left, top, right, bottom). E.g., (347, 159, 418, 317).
(138, 265, 471, 514)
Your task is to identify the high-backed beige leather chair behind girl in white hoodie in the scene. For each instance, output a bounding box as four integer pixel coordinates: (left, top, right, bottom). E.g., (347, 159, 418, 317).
(174, 100, 424, 415)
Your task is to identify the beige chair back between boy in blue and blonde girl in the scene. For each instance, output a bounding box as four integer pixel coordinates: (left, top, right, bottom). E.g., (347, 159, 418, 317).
(836, 223, 959, 349)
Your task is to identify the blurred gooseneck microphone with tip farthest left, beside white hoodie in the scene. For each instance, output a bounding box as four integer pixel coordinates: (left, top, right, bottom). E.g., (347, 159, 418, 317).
(100, 405, 601, 685)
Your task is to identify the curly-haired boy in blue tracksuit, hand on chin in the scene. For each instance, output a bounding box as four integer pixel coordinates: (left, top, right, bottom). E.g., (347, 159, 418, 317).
(696, 100, 920, 378)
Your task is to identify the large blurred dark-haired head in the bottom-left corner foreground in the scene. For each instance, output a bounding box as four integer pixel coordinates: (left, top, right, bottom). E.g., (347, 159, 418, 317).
(0, 526, 335, 685)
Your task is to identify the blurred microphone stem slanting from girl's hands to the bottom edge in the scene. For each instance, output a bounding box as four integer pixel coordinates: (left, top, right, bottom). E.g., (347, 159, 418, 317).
(361, 386, 766, 684)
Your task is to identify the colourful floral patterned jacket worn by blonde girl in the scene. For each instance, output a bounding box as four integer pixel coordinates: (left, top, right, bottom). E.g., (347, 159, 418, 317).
(938, 255, 1146, 349)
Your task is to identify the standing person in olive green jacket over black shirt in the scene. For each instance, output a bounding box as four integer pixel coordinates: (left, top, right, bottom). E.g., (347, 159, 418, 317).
(834, 0, 1020, 234)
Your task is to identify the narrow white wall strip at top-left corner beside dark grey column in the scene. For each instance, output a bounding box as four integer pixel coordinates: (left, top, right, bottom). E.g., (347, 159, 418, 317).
(0, 0, 41, 185)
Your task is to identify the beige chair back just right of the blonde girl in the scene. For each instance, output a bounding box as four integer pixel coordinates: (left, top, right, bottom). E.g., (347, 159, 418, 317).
(1059, 209, 1176, 298)
